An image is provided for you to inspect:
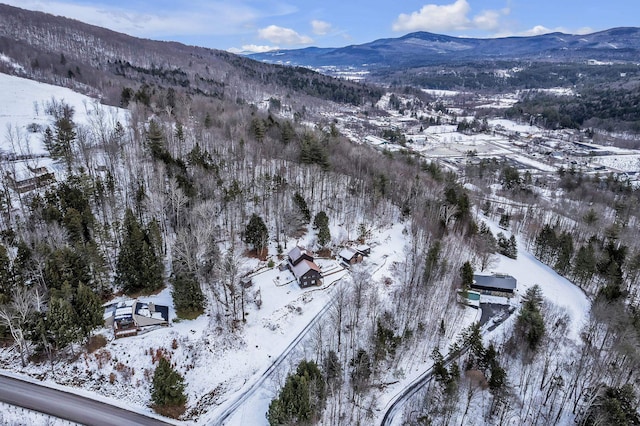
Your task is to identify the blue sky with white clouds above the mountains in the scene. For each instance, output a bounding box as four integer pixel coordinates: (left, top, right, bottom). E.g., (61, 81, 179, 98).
(5, 0, 640, 52)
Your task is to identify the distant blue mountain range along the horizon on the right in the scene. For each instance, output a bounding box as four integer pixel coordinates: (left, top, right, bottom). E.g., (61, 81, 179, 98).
(247, 27, 640, 69)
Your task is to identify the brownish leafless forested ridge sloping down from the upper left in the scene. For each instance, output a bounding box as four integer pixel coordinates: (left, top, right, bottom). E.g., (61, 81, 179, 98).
(0, 5, 381, 107)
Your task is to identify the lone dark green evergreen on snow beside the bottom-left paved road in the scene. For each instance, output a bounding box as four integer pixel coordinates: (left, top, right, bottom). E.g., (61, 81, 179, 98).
(151, 357, 187, 417)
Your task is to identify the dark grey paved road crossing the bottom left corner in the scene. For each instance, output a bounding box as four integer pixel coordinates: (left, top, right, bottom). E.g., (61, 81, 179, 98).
(0, 374, 171, 426)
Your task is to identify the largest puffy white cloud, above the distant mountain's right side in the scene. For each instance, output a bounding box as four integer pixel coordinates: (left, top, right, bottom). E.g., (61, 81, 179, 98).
(392, 0, 510, 32)
